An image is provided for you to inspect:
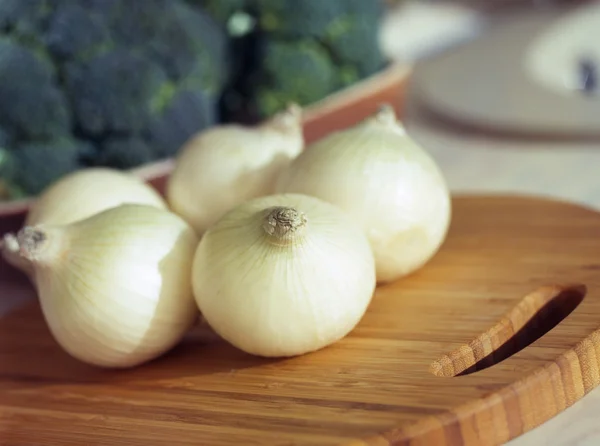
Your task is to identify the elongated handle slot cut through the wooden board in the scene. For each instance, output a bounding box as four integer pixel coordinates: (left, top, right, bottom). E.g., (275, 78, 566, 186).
(429, 284, 587, 377)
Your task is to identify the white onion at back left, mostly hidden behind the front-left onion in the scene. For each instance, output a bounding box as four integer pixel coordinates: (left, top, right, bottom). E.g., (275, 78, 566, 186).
(0, 167, 167, 275)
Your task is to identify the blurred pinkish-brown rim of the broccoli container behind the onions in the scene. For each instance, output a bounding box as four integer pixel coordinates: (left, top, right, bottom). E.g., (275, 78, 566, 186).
(0, 62, 412, 218)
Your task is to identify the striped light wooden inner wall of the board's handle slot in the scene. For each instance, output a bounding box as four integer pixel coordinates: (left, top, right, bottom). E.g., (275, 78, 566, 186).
(429, 284, 587, 378)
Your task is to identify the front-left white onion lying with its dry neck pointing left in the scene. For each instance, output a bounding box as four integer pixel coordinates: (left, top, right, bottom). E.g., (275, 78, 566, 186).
(5, 204, 198, 368)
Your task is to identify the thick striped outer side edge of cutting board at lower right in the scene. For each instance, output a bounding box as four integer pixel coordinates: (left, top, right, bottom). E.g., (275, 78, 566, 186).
(344, 329, 600, 446)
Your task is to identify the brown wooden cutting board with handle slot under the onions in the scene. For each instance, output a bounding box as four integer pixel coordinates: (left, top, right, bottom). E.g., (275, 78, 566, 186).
(0, 196, 600, 446)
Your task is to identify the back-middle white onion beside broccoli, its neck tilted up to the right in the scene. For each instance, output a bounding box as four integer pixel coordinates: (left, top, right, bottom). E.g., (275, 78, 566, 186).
(166, 104, 304, 235)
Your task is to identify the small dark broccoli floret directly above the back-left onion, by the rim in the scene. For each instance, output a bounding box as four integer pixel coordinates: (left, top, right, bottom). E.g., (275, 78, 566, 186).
(96, 137, 155, 169)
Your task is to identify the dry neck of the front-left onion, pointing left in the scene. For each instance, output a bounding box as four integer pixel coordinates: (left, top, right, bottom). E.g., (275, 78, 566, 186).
(16, 226, 63, 265)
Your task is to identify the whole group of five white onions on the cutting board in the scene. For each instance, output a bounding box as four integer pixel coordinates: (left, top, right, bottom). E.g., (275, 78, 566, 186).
(2, 105, 451, 368)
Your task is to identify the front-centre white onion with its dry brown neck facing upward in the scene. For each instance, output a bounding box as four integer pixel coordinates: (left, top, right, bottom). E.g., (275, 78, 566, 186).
(192, 194, 376, 357)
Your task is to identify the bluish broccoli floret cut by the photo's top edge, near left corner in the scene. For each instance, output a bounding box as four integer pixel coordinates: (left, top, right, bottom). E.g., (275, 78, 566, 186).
(45, 2, 111, 60)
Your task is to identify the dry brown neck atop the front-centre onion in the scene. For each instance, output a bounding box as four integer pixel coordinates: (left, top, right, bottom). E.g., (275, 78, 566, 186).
(262, 206, 308, 246)
